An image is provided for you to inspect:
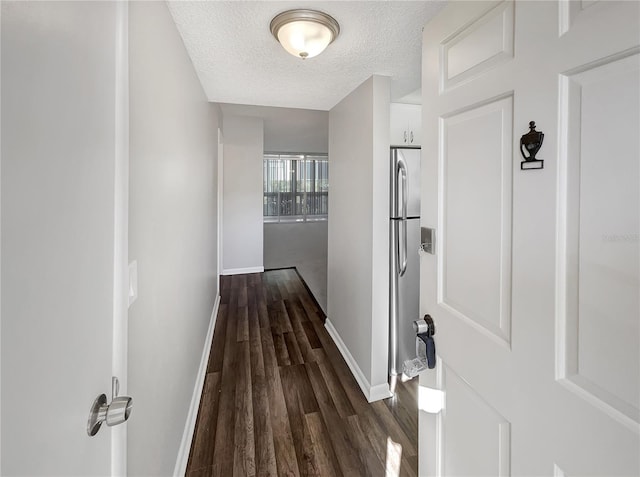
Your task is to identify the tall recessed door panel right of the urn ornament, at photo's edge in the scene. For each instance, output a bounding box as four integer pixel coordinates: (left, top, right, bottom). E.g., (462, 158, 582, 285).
(556, 47, 640, 433)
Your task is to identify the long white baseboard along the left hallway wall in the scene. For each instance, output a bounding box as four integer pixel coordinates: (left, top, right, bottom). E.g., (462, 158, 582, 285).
(173, 294, 220, 477)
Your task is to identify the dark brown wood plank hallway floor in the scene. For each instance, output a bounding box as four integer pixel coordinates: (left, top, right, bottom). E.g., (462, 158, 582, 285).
(187, 269, 418, 477)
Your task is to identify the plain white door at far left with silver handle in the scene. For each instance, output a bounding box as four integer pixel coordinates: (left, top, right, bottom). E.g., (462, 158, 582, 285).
(0, 1, 129, 476)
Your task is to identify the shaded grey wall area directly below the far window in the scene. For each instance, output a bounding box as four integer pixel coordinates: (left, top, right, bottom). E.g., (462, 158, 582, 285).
(264, 221, 328, 313)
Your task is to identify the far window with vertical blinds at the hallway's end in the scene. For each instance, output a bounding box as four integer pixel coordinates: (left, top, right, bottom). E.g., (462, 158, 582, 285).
(263, 154, 329, 222)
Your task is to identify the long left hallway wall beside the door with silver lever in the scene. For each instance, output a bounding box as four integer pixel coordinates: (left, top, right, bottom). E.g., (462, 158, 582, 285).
(128, 2, 218, 475)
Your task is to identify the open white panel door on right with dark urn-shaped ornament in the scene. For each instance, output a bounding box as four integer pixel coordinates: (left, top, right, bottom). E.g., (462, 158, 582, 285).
(419, 1, 640, 477)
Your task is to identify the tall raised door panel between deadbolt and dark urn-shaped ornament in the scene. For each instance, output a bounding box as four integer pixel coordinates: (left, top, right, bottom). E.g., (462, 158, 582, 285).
(437, 93, 513, 348)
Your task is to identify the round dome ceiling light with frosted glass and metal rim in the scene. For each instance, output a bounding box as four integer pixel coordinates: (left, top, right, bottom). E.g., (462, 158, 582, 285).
(271, 9, 340, 60)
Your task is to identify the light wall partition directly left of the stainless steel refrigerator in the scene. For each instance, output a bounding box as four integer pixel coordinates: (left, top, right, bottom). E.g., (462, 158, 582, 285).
(328, 76, 390, 399)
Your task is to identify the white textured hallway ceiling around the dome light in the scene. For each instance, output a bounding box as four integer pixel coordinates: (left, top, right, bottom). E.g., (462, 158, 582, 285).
(168, 0, 442, 110)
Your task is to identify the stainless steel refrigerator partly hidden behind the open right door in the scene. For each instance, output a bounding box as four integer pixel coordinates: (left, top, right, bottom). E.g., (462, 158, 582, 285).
(389, 147, 420, 380)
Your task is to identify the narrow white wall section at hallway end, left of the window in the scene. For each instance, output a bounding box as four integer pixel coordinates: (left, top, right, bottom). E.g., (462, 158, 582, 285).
(222, 115, 264, 274)
